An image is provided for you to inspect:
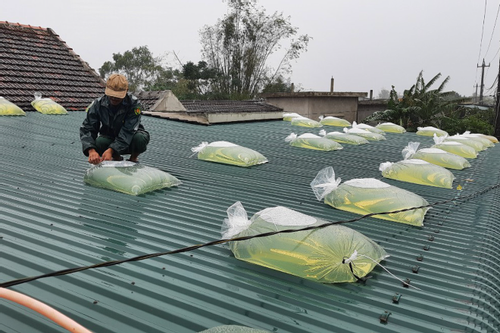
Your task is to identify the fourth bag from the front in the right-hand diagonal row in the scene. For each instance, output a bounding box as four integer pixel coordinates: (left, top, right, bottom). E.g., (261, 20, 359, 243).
(402, 142, 470, 170)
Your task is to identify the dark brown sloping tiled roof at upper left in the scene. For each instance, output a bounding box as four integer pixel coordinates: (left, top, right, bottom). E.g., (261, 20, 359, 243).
(0, 22, 104, 111)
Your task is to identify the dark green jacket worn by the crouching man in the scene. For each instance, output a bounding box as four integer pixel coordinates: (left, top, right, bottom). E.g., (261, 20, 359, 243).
(80, 93, 145, 156)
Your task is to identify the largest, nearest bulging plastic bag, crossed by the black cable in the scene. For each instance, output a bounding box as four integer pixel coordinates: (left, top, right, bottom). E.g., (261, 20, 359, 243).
(222, 202, 388, 283)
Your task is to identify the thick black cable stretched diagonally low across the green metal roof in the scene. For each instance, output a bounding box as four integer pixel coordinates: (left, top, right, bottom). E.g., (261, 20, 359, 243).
(0, 183, 500, 288)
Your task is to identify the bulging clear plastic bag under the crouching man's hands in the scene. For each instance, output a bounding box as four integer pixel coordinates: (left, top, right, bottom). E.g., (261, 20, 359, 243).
(83, 161, 182, 195)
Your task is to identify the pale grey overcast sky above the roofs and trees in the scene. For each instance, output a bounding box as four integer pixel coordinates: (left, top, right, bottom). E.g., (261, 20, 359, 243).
(0, 0, 500, 97)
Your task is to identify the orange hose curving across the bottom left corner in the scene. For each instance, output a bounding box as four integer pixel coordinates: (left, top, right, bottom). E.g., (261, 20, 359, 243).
(0, 288, 92, 333)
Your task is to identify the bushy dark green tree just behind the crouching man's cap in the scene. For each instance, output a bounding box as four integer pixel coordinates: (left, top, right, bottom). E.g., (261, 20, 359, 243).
(99, 46, 176, 91)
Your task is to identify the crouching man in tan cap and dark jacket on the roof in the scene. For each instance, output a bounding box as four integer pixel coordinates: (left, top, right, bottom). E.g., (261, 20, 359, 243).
(80, 74, 149, 164)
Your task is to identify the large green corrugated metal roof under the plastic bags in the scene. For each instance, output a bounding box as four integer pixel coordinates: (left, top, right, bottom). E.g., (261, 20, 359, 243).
(0, 112, 500, 333)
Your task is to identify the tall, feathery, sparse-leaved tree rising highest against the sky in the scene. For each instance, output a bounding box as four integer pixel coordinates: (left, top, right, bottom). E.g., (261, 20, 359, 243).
(200, 0, 310, 99)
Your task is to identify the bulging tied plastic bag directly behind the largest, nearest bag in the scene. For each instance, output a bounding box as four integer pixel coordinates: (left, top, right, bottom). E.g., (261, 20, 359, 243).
(311, 167, 429, 226)
